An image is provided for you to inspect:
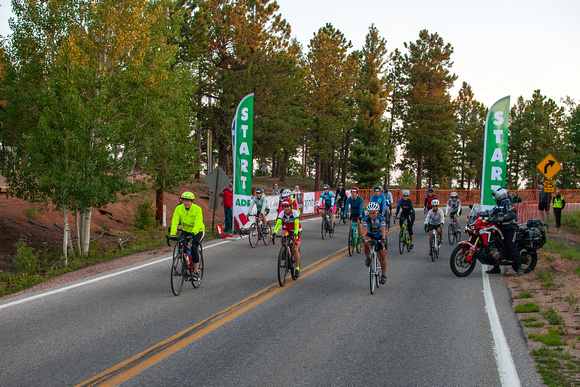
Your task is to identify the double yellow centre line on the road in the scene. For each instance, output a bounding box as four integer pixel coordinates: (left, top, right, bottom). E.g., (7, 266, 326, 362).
(78, 247, 346, 386)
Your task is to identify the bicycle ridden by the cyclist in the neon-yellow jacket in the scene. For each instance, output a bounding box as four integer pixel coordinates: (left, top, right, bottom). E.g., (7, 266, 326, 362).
(165, 235, 204, 296)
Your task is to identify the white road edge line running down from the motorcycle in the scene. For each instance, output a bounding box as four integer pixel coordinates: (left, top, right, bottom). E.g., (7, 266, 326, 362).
(481, 265, 521, 387)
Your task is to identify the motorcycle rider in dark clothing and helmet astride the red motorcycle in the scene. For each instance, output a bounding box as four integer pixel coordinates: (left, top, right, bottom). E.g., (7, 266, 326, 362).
(486, 188, 524, 277)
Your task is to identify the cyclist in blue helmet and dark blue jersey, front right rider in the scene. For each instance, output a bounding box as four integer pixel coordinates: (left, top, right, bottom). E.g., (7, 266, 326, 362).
(361, 202, 387, 284)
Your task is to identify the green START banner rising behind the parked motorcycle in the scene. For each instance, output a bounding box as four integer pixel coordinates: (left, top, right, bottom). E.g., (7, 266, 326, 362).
(481, 95, 510, 210)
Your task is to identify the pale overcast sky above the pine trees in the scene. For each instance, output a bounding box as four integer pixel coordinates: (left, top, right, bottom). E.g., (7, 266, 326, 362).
(0, 0, 580, 107)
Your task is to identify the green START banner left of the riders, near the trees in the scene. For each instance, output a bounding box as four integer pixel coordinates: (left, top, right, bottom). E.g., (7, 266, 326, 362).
(232, 94, 254, 228)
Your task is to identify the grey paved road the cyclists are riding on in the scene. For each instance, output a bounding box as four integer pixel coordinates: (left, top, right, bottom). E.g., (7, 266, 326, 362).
(0, 214, 542, 386)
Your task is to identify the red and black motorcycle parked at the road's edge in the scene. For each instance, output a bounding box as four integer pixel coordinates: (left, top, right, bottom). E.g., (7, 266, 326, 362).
(450, 204, 546, 277)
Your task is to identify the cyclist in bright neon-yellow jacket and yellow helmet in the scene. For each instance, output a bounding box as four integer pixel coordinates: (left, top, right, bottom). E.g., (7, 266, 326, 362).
(170, 191, 205, 281)
